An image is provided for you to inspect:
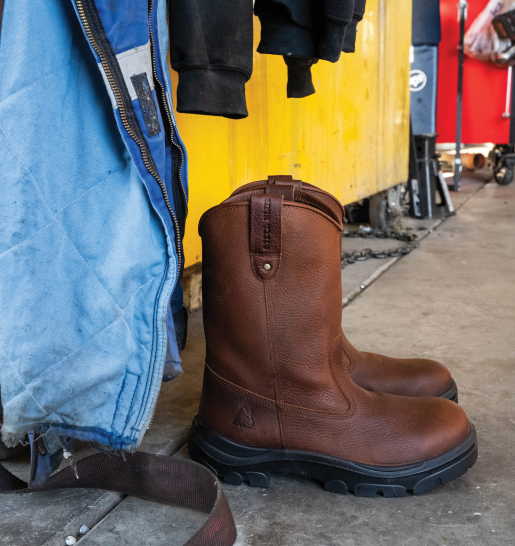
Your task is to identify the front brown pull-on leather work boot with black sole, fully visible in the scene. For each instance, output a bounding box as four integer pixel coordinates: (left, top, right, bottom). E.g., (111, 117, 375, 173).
(189, 181, 477, 496)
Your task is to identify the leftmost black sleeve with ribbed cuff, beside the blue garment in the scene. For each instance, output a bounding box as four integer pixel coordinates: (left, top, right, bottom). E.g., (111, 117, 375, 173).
(169, 0, 253, 119)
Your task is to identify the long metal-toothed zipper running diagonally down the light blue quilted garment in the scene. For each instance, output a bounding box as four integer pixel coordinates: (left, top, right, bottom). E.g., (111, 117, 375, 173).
(76, 0, 184, 264)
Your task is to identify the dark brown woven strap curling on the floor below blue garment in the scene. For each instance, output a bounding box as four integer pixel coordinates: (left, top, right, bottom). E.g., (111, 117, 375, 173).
(0, 452, 236, 546)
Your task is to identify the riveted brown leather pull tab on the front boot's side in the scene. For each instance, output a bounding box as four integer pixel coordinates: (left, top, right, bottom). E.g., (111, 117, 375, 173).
(250, 193, 283, 281)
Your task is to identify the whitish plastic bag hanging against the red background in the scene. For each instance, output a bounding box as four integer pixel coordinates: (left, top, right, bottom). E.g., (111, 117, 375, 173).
(465, 0, 515, 64)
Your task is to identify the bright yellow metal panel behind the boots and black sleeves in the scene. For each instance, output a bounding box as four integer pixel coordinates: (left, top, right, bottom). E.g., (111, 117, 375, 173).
(172, 0, 411, 266)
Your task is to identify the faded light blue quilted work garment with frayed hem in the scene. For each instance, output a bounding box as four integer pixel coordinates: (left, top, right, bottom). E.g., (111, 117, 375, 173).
(0, 0, 187, 449)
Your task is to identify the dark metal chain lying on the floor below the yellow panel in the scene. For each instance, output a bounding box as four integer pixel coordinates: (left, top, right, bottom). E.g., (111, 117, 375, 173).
(341, 226, 420, 269)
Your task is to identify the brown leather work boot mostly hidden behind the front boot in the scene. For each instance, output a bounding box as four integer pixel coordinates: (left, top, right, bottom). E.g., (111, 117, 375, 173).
(232, 175, 458, 402)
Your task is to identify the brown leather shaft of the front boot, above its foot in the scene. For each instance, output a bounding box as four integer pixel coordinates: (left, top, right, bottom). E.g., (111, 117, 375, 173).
(199, 187, 348, 410)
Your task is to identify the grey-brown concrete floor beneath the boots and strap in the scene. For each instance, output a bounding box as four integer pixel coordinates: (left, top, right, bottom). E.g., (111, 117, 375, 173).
(0, 176, 515, 546)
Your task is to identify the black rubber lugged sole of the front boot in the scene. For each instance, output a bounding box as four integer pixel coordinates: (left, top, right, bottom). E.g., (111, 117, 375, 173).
(188, 418, 477, 497)
